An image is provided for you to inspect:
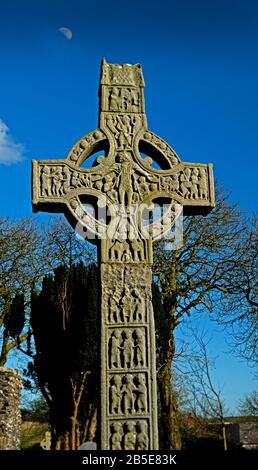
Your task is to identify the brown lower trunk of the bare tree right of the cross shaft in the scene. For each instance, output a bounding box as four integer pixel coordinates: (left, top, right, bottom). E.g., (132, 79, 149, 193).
(157, 329, 182, 450)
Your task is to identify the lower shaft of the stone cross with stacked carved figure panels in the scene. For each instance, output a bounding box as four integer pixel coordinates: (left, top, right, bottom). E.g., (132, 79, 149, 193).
(101, 262, 156, 450)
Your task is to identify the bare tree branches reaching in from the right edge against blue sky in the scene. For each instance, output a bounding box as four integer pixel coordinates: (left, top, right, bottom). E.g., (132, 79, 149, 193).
(216, 216, 258, 367)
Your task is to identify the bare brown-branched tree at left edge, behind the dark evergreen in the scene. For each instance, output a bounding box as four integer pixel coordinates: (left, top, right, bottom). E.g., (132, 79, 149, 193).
(0, 218, 95, 366)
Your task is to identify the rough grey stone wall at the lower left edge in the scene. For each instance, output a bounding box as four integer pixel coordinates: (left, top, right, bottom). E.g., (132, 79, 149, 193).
(0, 367, 22, 450)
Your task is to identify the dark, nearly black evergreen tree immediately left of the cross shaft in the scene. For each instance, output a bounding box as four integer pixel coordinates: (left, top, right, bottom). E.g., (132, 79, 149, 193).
(31, 263, 99, 449)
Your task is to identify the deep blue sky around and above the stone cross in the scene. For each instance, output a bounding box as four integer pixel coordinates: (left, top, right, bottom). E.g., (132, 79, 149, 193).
(0, 0, 258, 407)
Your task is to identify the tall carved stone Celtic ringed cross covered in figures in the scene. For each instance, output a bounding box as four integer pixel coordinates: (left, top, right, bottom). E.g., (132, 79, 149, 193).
(32, 60, 214, 450)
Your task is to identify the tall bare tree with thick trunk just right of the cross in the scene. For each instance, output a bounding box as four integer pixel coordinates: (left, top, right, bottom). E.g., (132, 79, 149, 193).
(154, 188, 257, 449)
